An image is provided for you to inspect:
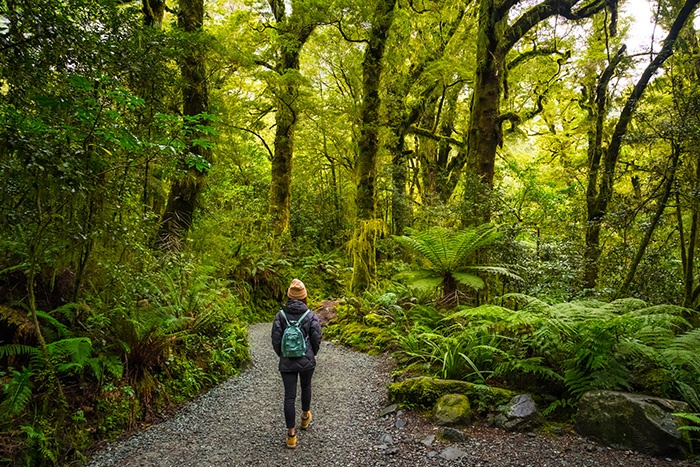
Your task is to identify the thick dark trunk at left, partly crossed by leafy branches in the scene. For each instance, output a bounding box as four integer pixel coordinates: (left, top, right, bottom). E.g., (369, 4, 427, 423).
(158, 0, 211, 249)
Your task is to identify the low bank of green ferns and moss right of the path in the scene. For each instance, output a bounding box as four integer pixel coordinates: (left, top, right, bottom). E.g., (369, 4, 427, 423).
(329, 293, 700, 414)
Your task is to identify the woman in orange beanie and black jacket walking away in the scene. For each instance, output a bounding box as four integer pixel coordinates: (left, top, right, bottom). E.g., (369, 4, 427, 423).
(272, 279, 321, 449)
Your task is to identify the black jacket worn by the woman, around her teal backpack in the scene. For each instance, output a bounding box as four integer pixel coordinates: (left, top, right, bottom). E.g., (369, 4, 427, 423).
(272, 300, 322, 373)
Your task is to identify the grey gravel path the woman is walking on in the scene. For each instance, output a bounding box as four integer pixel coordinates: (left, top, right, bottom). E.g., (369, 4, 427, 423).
(89, 323, 699, 467)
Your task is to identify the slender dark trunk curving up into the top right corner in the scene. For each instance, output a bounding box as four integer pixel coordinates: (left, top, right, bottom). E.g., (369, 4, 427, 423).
(584, 0, 700, 289)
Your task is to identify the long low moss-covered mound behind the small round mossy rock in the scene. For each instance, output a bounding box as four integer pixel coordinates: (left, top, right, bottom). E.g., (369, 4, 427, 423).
(388, 376, 516, 412)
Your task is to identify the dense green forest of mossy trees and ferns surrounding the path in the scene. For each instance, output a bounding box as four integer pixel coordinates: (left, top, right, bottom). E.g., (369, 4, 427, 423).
(0, 0, 700, 465)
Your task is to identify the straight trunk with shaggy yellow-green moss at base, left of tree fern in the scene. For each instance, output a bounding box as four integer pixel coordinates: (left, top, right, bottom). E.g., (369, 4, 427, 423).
(351, 0, 396, 292)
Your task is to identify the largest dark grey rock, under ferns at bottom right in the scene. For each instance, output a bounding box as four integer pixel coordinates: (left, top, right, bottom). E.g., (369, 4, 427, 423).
(575, 390, 690, 458)
